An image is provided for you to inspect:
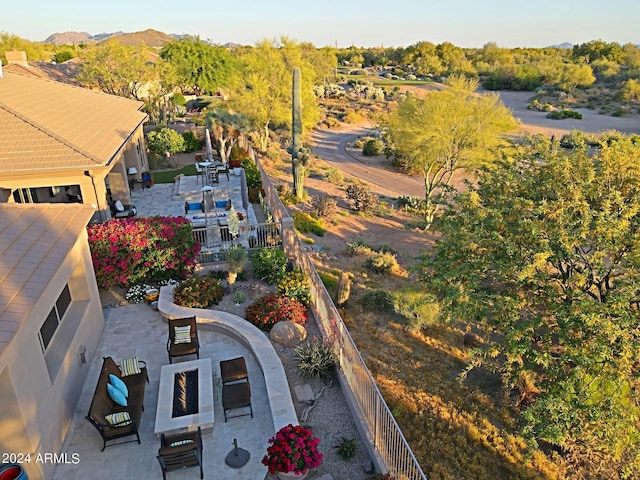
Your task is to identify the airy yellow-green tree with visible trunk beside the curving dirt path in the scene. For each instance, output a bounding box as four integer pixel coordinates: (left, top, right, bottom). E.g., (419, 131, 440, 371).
(387, 76, 517, 229)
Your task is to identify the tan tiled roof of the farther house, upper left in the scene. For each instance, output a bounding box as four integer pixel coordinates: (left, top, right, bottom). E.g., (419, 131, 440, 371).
(0, 69, 147, 172)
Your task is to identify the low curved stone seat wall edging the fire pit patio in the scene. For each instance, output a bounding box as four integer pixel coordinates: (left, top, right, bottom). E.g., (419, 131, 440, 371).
(158, 286, 298, 432)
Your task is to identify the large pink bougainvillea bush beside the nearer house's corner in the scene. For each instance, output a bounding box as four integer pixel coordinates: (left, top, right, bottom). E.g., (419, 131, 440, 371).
(87, 217, 200, 288)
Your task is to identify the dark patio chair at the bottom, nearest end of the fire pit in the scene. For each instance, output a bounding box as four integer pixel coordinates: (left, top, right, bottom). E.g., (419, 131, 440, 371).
(157, 427, 204, 480)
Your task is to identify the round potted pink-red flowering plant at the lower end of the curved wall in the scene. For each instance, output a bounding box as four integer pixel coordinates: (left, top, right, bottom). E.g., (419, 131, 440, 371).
(262, 424, 322, 475)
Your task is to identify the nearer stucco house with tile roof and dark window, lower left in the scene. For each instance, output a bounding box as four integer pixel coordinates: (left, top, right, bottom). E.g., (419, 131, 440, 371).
(0, 203, 105, 480)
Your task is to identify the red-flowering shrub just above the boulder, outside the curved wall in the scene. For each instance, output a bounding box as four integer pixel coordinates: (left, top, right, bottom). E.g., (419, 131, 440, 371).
(244, 293, 307, 331)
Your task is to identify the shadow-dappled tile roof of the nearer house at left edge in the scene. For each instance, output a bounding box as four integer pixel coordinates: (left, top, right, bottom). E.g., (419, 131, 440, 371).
(0, 203, 94, 354)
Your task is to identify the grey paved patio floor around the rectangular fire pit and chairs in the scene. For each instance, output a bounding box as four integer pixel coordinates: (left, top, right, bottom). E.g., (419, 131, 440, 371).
(54, 306, 275, 480)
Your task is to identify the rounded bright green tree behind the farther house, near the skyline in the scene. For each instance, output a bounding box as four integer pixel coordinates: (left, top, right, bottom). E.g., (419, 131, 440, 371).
(160, 37, 236, 95)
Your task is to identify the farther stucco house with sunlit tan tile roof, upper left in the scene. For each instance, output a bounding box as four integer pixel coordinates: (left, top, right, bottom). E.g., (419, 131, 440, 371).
(0, 65, 149, 221)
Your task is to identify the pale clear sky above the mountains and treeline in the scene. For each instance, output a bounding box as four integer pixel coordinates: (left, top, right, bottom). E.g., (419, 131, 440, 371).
(6, 0, 640, 48)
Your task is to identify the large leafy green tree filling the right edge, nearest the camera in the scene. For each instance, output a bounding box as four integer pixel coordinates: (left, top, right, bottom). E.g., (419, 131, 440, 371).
(421, 136, 640, 478)
